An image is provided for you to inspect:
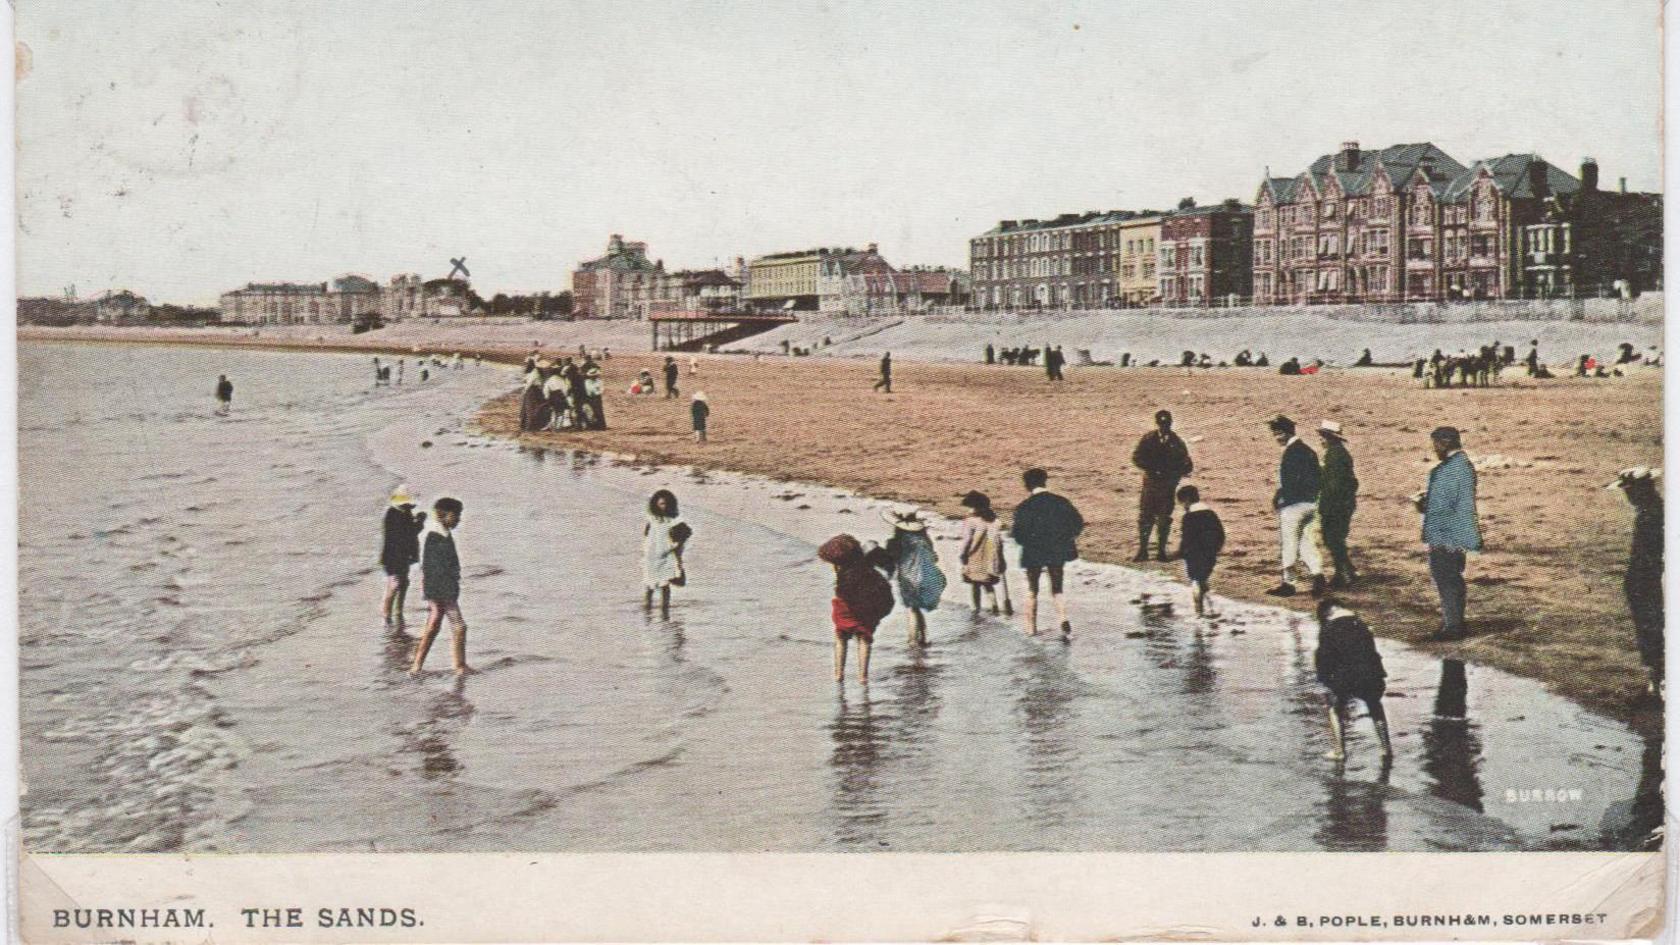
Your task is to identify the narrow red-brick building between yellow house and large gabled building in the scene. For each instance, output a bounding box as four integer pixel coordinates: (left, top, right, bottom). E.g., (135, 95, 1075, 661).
(1156, 200, 1253, 306)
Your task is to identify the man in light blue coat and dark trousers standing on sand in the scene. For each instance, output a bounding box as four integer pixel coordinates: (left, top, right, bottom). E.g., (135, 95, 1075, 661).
(1415, 427, 1482, 641)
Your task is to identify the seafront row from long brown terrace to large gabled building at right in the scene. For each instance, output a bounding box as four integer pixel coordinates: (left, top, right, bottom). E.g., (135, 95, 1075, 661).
(969, 141, 1663, 309)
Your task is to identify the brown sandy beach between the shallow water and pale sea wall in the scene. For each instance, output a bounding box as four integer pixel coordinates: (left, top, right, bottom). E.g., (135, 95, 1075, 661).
(479, 355, 1662, 723)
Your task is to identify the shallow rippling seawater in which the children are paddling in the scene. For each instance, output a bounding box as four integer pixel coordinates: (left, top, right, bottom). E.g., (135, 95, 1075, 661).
(18, 345, 1660, 851)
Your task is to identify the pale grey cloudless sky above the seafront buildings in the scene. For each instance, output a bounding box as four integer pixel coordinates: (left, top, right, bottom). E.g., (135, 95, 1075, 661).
(15, 0, 1662, 304)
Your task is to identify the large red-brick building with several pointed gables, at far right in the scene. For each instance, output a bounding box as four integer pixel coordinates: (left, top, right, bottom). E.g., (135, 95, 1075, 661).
(1253, 141, 1662, 304)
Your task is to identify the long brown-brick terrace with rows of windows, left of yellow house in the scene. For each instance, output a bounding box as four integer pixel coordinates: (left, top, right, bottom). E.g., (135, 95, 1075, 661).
(968, 210, 1159, 309)
